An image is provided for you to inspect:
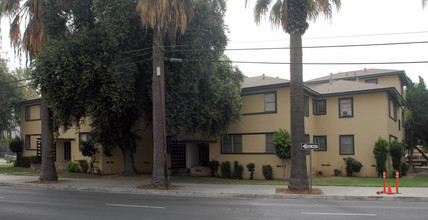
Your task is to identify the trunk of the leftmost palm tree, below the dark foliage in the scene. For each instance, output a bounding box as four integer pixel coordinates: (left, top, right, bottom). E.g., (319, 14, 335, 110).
(39, 100, 58, 181)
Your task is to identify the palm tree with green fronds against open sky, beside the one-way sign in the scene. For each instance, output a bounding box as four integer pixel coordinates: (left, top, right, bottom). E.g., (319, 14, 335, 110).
(245, 0, 341, 191)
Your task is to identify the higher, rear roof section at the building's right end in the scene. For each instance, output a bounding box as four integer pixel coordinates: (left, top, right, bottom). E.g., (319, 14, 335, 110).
(305, 69, 410, 86)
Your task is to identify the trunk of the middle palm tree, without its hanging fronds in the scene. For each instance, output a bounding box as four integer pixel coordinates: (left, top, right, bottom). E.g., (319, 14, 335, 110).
(152, 28, 169, 186)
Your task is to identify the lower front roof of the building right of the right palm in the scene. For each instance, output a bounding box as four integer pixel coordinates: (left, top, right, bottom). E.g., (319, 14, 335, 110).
(311, 80, 406, 106)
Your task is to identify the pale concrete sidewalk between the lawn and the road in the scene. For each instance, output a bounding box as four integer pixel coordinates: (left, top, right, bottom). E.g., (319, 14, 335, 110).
(0, 174, 428, 202)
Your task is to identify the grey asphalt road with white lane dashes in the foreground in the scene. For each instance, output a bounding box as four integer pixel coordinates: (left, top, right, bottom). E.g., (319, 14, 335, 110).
(0, 187, 428, 220)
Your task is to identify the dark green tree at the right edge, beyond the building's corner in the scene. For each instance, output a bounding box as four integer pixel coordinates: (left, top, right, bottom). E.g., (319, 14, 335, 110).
(404, 77, 428, 172)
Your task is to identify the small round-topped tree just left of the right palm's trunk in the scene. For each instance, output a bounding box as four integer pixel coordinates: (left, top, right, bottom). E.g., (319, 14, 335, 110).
(272, 129, 291, 180)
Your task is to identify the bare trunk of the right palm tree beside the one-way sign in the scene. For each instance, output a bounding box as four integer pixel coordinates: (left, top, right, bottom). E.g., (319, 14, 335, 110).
(288, 32, 309, 191)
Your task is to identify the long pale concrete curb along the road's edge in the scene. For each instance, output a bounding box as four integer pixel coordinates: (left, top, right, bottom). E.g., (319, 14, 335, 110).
(0, 183, 428, 202)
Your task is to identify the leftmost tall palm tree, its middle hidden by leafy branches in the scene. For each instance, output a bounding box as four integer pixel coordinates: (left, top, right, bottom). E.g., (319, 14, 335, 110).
(0, 0, 58, 181)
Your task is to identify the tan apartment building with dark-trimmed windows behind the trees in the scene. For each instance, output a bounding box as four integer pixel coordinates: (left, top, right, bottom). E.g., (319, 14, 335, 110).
(21, 69, 409, 179)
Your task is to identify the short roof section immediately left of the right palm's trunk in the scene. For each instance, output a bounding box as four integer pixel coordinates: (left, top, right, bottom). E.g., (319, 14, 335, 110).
(241, 74, 290, 92)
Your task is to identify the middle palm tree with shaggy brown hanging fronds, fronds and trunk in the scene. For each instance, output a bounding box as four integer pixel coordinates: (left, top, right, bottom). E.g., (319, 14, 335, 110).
(137, 0, 193, 187)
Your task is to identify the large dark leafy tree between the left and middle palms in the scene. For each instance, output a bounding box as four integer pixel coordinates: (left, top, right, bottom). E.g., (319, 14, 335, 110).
(33, 0, 154, 175)
